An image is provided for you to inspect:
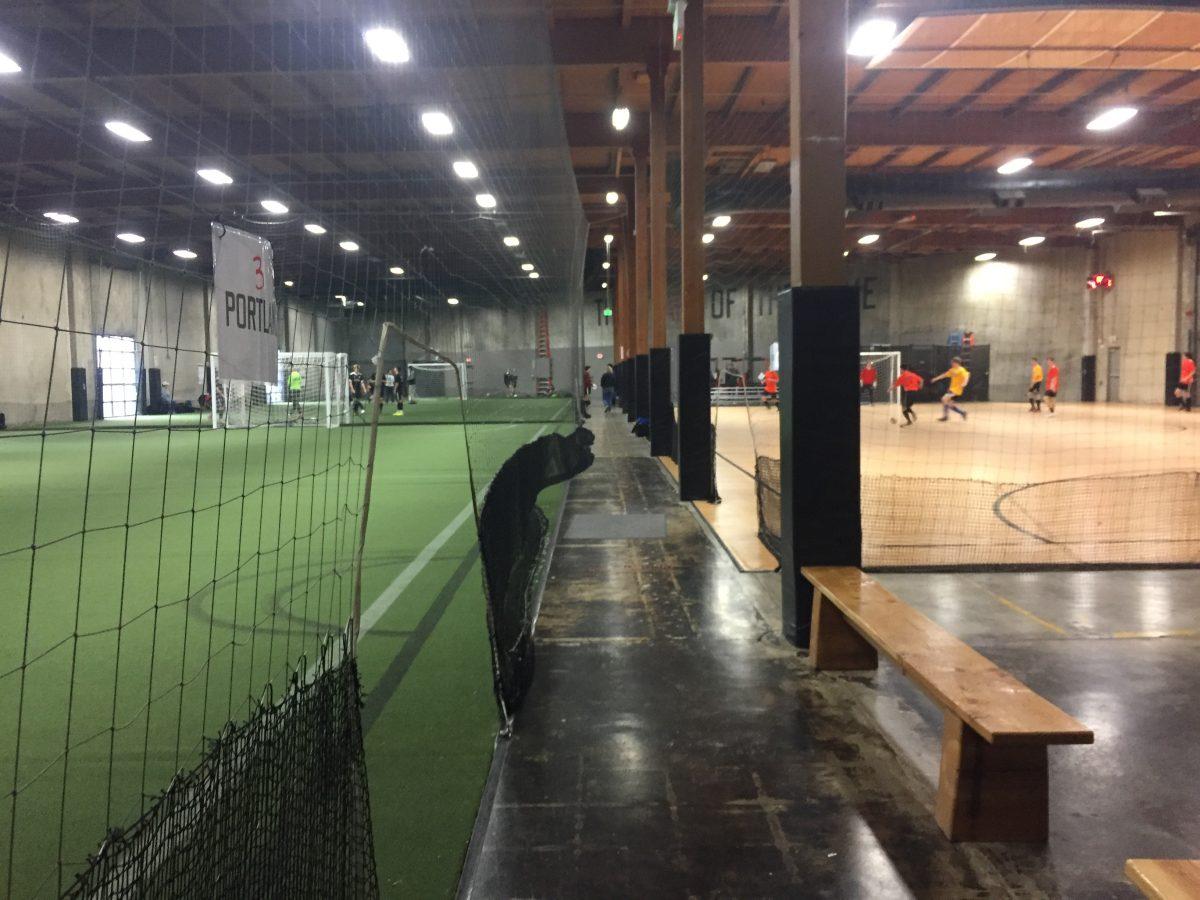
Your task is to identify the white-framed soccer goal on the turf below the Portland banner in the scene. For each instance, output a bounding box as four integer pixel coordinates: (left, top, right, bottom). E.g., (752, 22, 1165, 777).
(211, 352, 350, 428)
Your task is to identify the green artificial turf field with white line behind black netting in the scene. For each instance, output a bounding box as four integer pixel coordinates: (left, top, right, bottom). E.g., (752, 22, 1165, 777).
(0, 401, 572, 896)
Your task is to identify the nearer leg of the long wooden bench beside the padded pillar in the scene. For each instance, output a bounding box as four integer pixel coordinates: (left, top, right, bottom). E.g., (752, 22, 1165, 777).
(936, 713, 1050, 841)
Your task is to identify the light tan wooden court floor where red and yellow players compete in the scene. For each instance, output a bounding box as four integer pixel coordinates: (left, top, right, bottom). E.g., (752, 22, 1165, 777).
(701, 403, 1200, 569)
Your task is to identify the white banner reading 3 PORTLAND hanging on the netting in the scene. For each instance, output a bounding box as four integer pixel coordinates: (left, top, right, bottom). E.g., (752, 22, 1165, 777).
(212, 222, 280, 384)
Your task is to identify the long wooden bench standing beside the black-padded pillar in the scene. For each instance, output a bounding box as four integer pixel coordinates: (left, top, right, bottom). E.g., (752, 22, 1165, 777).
(802, 566, 1094, 841)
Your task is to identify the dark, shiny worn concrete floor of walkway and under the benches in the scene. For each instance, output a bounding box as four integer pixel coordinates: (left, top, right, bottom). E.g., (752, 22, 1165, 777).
(464, 415, 1200, 898)
